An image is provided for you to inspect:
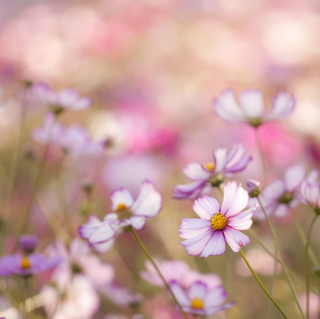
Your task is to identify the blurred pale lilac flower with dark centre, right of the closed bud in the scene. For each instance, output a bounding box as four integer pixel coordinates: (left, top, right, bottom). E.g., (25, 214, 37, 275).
(254, 165, 316, 219)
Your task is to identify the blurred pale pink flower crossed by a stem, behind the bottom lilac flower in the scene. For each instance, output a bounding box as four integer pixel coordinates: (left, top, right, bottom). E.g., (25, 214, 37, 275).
(140, 260, 221, 289)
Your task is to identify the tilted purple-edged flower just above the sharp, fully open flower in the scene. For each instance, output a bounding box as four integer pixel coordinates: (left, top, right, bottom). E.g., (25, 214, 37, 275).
(173, 144, 252, 200)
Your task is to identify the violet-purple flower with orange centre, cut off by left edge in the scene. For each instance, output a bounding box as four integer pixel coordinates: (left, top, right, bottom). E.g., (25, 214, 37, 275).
(0, 253, 62, 277)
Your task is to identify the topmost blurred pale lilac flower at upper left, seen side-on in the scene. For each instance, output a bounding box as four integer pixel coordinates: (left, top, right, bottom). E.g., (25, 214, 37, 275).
(32, 82, 92, 115)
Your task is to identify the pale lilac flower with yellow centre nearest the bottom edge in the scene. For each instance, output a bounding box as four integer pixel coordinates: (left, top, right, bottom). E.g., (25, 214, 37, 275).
(169, 281, 234, 316)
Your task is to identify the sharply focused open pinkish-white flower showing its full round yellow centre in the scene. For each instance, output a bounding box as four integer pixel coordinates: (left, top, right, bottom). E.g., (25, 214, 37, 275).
(179, 182, 255, 257)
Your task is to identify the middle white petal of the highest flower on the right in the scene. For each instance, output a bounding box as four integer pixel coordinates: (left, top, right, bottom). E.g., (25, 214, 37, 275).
(240, 90, 263, 119)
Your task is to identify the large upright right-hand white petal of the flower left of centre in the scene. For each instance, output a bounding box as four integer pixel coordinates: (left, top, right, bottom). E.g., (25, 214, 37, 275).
(132, 181, 162, 217)
